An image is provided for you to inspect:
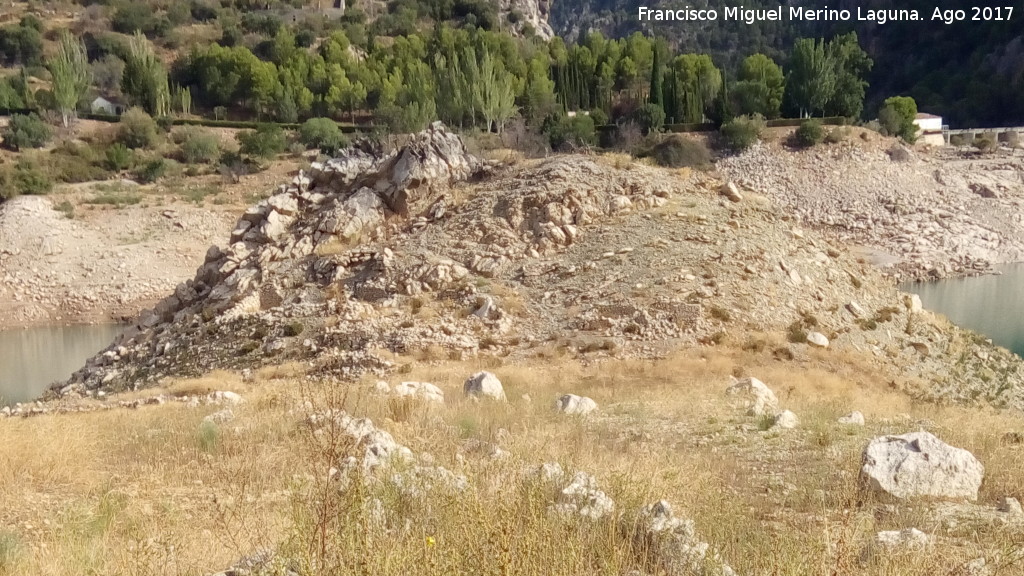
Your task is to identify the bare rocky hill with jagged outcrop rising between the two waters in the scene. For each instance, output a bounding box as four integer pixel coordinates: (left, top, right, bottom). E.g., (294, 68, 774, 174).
(55, 125, 1024, 407)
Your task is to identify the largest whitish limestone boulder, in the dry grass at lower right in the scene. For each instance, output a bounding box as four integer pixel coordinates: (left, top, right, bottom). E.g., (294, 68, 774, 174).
(860, 430, 985, 501)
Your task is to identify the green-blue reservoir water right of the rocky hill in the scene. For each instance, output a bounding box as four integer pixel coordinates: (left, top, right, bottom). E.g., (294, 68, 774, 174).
(900, 264, 1024, 357)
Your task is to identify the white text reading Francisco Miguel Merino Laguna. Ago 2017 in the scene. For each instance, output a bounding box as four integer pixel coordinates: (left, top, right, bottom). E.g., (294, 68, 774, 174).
(637, 6, 1014, 25)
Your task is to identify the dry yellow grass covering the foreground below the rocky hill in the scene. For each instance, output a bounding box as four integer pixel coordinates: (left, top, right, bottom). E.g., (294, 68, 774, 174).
(0, 346, 1024, 576)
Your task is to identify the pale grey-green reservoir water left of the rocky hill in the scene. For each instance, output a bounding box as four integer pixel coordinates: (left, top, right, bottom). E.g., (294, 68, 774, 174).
(0, 324, 124, 406)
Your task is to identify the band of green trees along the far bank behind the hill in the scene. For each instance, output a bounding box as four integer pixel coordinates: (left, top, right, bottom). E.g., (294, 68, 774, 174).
(0, 3, 872, 144)
